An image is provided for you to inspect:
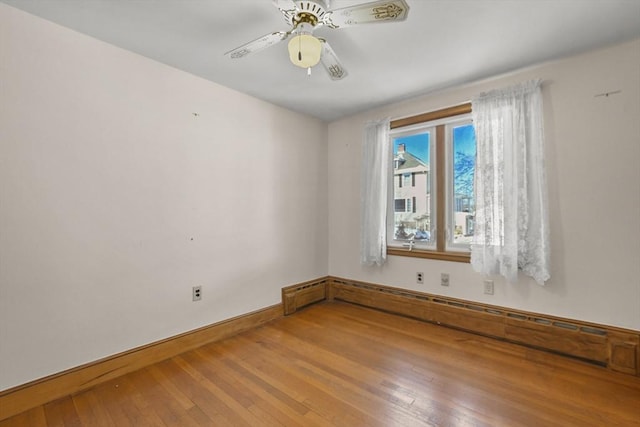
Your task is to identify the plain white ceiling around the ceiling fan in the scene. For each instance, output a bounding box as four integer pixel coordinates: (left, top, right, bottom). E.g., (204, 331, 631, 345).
(5, 0, 640, 121)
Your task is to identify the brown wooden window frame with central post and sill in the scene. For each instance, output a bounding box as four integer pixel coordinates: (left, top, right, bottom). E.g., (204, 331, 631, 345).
(387, 102, 471, 263)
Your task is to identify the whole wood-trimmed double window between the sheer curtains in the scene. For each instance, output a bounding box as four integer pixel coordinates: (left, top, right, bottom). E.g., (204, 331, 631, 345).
(387, 104, 476, 262)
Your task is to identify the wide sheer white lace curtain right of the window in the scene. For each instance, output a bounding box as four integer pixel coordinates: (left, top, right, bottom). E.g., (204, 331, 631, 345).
(471, 80, 550, 284)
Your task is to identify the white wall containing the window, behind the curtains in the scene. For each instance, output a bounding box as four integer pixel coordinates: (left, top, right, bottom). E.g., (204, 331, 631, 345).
(329, 40, 640, 330)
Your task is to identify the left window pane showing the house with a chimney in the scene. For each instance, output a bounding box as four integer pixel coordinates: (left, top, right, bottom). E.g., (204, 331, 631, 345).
(393, 131, 431, 243)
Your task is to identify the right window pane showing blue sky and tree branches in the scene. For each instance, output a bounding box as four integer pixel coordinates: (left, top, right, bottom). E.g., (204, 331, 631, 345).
(452, 124, 476, 246)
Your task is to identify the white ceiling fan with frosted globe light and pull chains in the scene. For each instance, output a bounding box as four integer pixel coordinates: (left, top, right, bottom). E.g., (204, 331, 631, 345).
(225, 0, 409, 80)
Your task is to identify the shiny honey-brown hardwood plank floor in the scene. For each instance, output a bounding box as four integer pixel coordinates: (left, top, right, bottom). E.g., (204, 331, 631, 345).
(0, 302, 640, 427)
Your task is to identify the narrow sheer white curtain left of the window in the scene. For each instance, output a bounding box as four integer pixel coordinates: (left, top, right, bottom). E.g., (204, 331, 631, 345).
(360, 119, 391, 265)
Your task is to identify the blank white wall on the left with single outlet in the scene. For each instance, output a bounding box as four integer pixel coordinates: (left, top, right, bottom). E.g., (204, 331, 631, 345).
(0, 4, 328, 390)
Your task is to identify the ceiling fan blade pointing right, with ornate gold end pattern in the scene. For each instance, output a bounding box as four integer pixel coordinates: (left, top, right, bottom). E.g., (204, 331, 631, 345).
(322, 0, 409, 28)
